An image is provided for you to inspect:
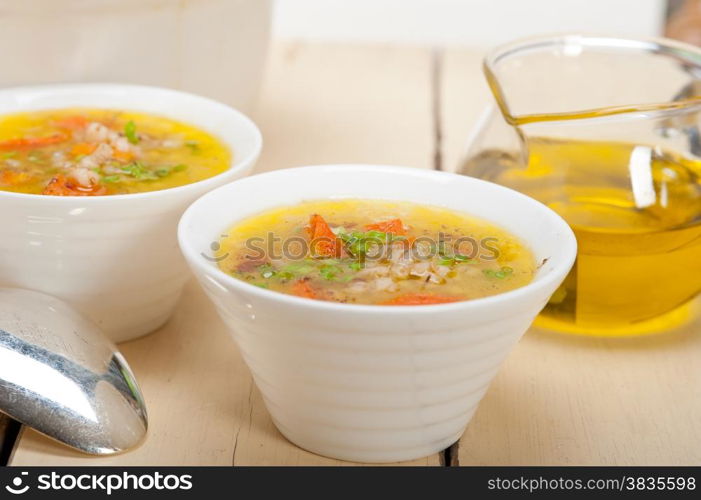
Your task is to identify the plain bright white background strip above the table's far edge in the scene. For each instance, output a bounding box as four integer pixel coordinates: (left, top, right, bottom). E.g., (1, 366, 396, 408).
(274, 0, 666, 48)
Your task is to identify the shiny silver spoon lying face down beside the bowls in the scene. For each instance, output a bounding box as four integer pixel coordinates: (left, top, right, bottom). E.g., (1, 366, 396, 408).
(0, 288, 148, 455)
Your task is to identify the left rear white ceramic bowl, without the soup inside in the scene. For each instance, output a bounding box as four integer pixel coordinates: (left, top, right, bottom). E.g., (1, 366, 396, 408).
(0, 84, 262, 342)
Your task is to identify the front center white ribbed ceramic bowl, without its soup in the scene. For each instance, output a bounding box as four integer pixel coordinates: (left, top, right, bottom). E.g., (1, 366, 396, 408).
(178, 165, 577, 462)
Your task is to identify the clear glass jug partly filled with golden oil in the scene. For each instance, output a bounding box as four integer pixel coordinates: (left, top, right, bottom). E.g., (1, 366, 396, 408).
(460, 36, 701, 335)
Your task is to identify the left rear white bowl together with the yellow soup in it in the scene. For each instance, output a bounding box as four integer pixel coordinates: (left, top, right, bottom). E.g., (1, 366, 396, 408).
(0, 84, 262, 342)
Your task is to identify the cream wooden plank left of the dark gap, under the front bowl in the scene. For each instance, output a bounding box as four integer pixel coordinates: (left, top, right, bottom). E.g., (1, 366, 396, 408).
(12, 44, 439, 465)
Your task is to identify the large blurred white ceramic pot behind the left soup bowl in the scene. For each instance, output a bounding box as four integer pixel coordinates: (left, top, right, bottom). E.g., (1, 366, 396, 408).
(0, 0, 272, 112)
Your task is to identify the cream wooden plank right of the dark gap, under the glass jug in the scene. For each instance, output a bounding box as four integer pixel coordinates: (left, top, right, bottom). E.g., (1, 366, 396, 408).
(441, 50, 701, 465)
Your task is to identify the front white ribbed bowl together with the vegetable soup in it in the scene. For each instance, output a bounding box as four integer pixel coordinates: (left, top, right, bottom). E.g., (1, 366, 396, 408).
(178, 165, 576, 462)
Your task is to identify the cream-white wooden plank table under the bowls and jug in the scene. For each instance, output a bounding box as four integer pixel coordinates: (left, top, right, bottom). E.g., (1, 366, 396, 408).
(0, 44, 701, 465)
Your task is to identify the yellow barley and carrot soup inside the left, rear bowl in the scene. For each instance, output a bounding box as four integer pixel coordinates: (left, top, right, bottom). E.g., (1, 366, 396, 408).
(0, 108, 232, 196)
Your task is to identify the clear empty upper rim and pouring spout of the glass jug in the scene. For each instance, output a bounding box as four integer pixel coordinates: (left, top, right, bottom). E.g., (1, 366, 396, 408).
(483, 35, 701, 126)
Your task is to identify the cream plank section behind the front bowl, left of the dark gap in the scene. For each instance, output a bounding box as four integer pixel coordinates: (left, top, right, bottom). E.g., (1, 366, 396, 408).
(256, 43, 433, 172)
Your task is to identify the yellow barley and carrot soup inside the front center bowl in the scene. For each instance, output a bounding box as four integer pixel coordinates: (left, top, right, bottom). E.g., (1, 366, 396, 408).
(217, 199, 536, 305)
